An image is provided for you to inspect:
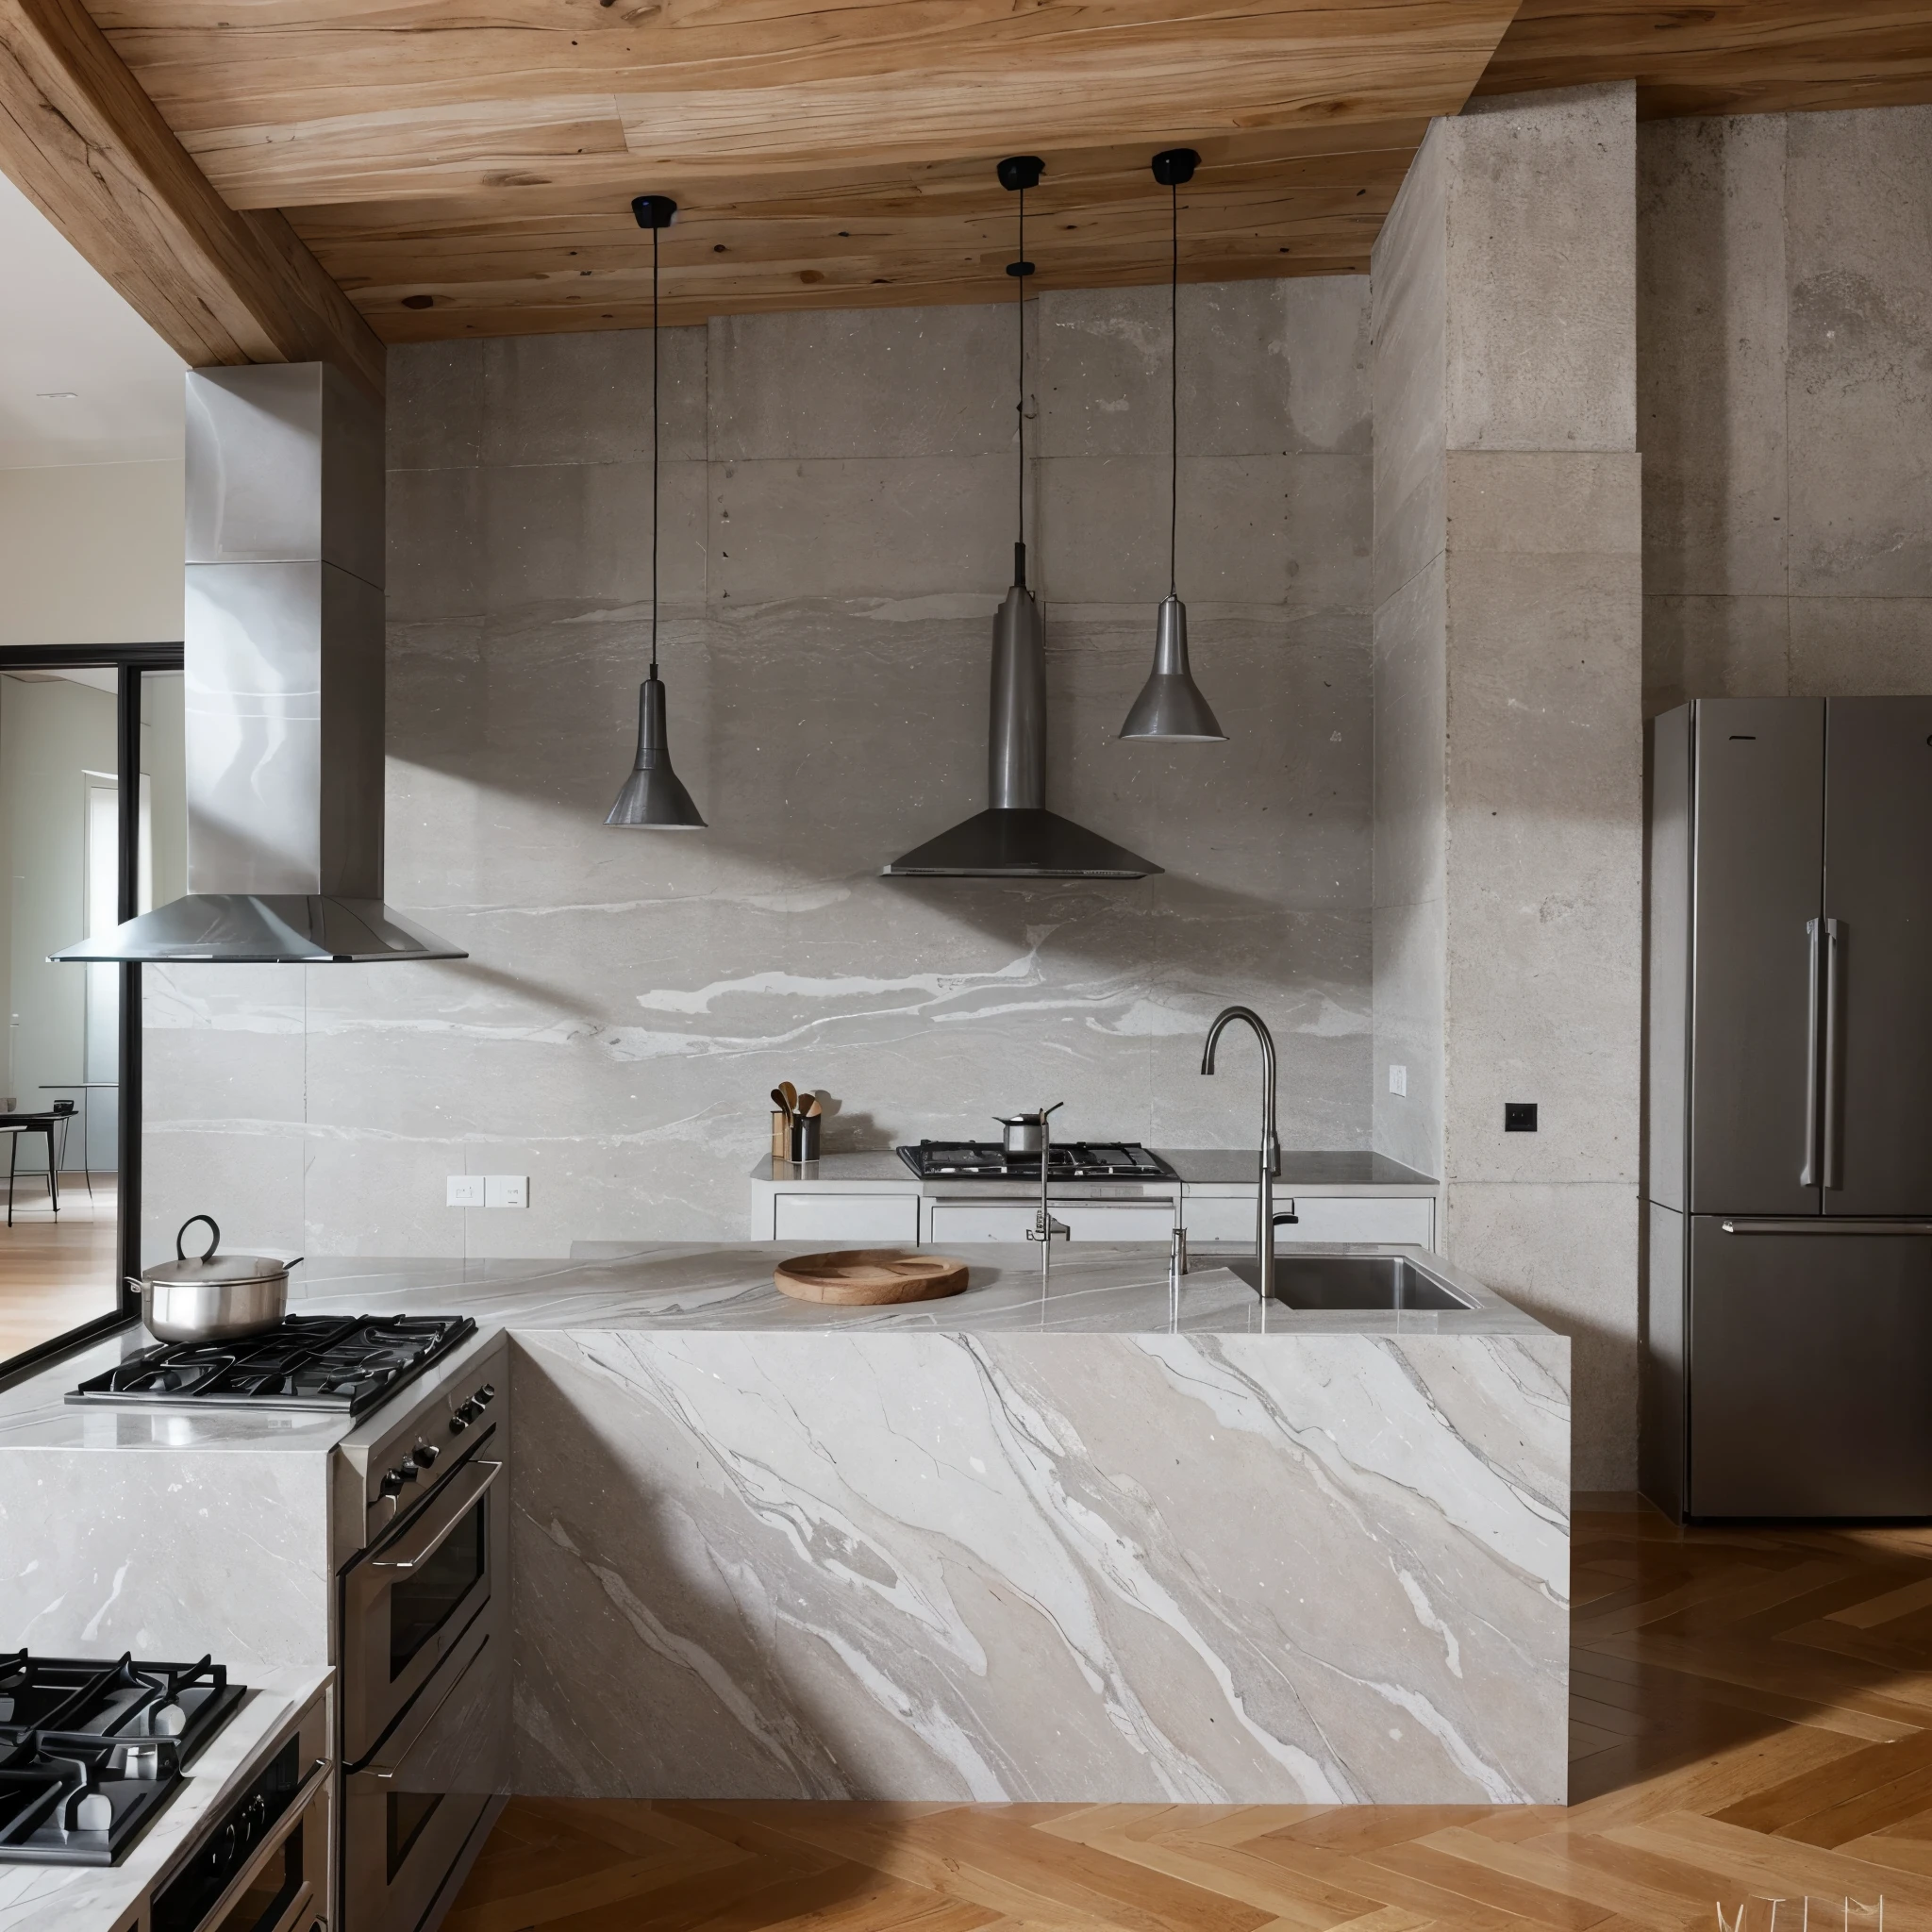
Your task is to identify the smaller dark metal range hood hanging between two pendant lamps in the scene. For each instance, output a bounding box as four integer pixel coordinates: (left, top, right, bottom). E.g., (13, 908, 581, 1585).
(883, 559, 1161, 879)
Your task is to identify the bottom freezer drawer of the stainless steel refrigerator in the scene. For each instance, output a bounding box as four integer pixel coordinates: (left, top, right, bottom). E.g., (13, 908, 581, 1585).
(1689, 1215, 1932, 1517)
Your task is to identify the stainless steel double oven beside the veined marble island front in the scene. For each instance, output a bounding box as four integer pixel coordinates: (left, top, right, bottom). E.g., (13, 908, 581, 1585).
(336, 1341, 510, 1932)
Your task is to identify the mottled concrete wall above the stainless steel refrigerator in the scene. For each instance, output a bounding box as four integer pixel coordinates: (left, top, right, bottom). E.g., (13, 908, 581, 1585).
(1637, 107, 1932, 713)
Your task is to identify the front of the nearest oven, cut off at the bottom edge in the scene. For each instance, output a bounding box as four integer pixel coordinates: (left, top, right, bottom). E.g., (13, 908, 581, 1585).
(147, 1692, 332, 1932)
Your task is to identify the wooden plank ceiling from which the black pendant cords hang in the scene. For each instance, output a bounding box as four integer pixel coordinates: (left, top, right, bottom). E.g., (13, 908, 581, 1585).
(11, 0, 1932, 341)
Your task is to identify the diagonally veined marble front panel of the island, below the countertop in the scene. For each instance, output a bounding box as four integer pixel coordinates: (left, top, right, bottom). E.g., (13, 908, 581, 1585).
(514, 1329, 1569, 1805)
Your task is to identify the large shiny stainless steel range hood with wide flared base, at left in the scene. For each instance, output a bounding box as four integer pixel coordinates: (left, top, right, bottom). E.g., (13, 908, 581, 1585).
(54, 363, 468, 964)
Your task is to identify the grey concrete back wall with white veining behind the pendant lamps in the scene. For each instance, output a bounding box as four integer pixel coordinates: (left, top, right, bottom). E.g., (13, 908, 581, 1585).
(147, 278, 1370, 1256)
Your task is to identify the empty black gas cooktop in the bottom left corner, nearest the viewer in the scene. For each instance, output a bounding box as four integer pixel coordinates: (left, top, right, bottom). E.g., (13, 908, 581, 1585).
(0, 1650, 247, 1864)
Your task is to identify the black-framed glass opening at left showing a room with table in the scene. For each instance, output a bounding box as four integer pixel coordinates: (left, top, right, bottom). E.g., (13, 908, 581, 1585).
(0, 645, 188, 1381)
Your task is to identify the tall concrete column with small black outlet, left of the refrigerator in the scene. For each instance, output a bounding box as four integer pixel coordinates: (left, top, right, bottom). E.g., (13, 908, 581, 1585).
(1372, 85, 1642, 1488)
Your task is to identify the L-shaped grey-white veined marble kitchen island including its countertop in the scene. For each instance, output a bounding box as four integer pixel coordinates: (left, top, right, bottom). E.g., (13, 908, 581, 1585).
(0, 1242, 1569, 1803)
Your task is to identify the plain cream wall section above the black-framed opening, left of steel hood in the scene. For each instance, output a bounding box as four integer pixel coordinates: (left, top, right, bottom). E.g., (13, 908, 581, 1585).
(0, 461, 182, 645)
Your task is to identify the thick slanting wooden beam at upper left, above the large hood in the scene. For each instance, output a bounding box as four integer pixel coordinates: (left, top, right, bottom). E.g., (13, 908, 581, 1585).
(0, 0, 385, 394)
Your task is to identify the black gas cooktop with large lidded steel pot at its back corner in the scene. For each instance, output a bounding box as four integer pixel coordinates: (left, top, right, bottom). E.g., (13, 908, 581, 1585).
(68, 1316, 477, 1416)
